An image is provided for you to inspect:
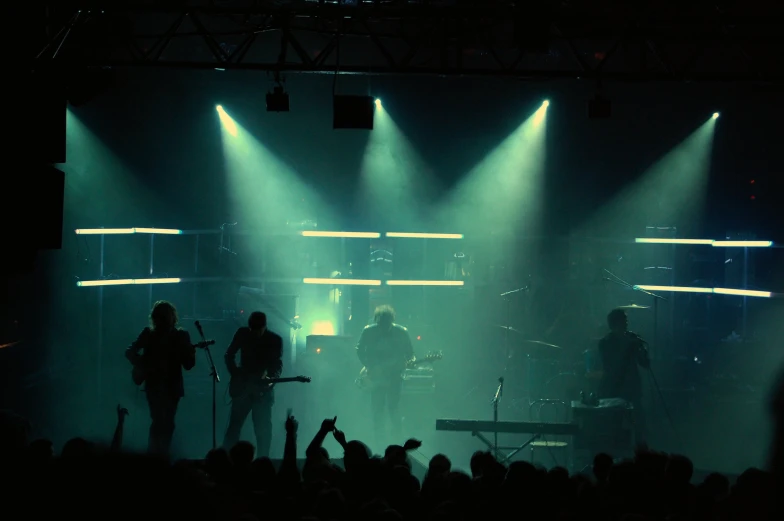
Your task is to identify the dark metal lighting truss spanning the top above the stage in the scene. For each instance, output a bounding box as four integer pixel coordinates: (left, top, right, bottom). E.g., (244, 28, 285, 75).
(33, 0, 784, 83)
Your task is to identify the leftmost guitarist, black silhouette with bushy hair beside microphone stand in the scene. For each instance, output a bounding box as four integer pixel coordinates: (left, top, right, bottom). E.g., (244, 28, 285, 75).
(125, 300, 196, 456)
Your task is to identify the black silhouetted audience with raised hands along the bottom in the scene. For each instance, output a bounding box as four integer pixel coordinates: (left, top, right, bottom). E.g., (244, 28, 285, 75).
(0, 389, 784, 521)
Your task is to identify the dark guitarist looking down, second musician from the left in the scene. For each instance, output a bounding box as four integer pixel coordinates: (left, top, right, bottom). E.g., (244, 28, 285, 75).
(223, 311, 283, 458)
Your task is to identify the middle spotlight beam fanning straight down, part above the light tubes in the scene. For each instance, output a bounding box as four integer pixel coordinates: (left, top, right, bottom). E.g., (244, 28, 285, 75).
(355, 100, 438, 229)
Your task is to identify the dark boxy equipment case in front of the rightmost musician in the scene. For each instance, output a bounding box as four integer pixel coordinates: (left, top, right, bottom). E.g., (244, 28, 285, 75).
(572, 399, 634, 454)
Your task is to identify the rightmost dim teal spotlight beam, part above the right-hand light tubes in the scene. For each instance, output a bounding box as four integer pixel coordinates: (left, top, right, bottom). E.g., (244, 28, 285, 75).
(576, 119, 716, 237)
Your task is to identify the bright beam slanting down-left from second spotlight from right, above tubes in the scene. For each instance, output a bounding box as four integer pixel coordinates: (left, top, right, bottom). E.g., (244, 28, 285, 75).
(438, 104, 547, 242)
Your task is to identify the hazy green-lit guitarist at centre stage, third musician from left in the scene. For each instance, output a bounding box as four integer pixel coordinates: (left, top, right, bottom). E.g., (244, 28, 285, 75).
(357, 306, 414, 445)
